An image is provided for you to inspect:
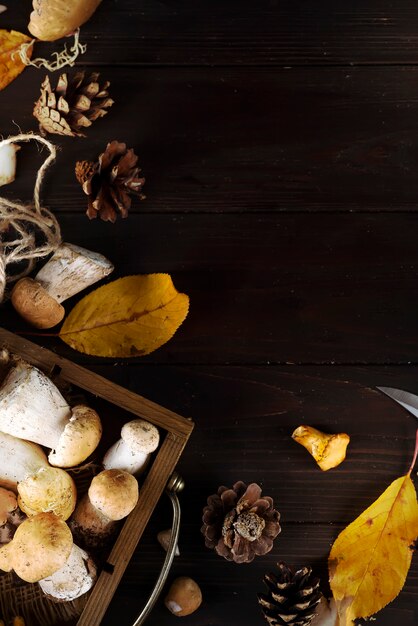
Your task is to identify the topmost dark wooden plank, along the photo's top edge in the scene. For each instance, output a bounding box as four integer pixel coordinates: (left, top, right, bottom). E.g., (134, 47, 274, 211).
(5, 0, 418, 66)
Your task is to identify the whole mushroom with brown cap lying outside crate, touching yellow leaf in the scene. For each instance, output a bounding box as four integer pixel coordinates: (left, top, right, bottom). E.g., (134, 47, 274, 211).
(12, 243, 114, 328)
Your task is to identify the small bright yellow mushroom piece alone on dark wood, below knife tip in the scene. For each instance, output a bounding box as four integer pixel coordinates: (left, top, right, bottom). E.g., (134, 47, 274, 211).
(292, 426, 350, 472)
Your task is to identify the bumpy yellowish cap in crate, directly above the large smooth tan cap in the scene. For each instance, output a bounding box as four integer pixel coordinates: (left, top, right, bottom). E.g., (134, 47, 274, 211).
(17, 467, 77, 520)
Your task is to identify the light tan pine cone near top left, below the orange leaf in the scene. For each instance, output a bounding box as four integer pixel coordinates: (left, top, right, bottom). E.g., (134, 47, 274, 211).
(33, 72, 113, 137)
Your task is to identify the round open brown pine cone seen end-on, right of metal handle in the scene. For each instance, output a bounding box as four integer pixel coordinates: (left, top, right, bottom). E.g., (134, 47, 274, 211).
(201, 481, 281, 563)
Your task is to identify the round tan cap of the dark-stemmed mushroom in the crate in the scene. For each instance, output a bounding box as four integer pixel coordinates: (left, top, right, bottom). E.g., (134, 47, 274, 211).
(88, 469, 138, 521)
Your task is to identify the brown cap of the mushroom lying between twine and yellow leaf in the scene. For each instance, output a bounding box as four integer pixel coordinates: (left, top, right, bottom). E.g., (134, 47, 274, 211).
(12, 278, 65, 328)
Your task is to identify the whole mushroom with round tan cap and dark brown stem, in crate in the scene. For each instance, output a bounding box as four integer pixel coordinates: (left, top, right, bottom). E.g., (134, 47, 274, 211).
(70, 469, 138, 548)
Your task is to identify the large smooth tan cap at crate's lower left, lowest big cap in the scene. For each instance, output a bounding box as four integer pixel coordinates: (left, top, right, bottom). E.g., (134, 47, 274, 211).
(0, 513, 73, 583)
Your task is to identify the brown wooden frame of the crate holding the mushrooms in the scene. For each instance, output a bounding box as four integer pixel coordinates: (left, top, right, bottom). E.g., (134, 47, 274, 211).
(0, 328, 194, 626)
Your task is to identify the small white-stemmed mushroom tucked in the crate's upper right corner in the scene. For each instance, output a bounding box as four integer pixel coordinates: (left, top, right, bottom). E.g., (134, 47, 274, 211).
(103, 419, 160, 475)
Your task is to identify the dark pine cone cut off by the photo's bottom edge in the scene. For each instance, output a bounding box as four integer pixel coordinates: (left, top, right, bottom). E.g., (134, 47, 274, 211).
(258, 562, 322, 626)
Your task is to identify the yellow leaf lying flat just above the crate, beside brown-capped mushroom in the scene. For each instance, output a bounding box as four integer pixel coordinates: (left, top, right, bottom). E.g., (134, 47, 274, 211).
(60, 274, 189, 357)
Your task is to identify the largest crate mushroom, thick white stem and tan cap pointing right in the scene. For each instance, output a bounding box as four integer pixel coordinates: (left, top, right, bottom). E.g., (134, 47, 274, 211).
(0, 361, 102, 467)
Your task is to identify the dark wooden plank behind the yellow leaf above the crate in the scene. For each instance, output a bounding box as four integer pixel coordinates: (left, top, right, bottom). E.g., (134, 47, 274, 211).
(2, 214, 418, 364)
